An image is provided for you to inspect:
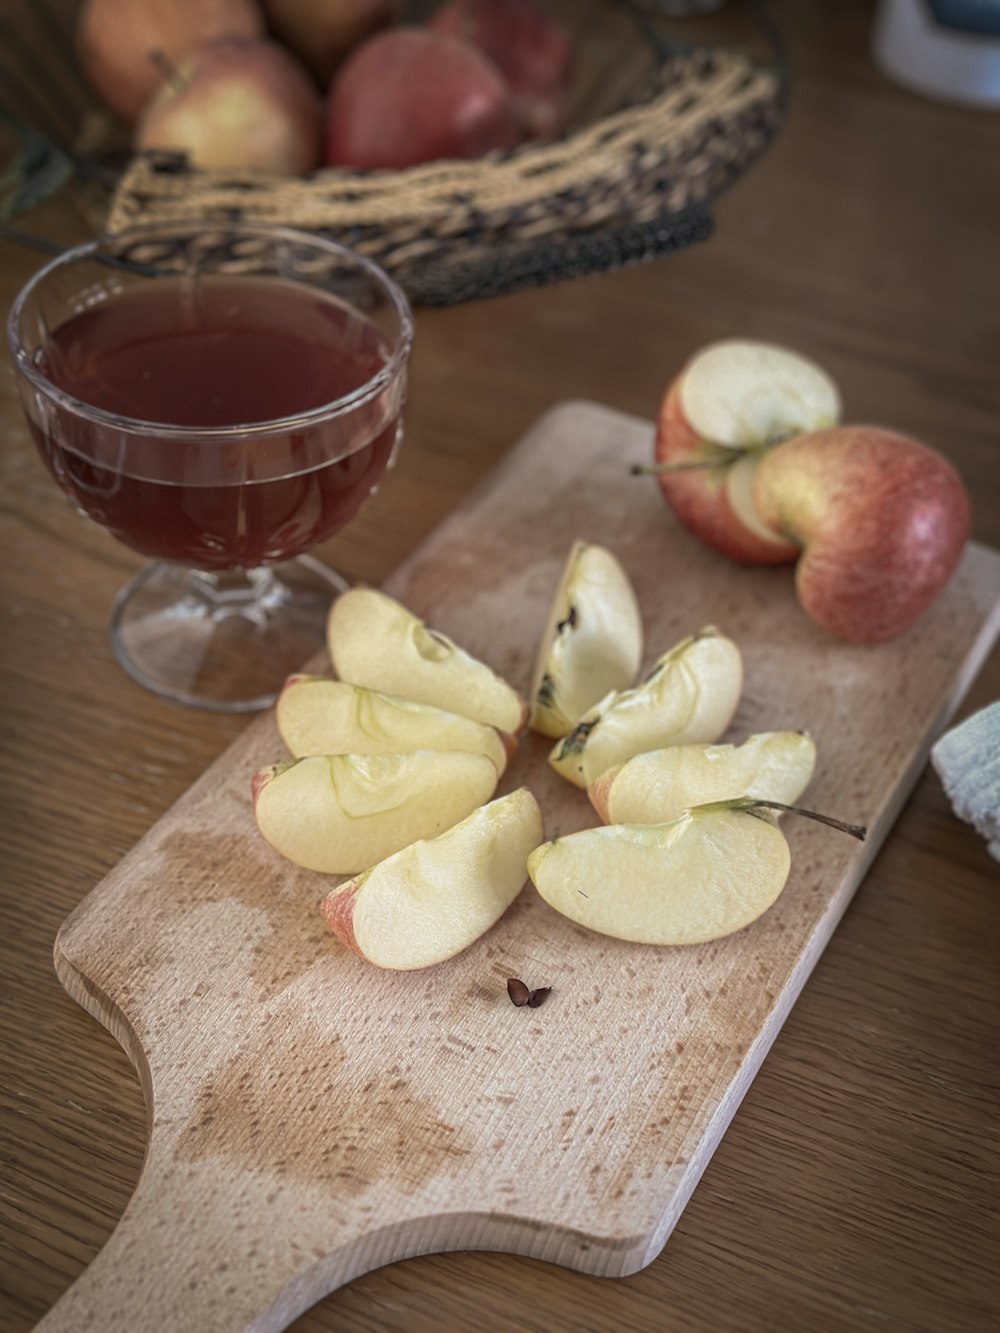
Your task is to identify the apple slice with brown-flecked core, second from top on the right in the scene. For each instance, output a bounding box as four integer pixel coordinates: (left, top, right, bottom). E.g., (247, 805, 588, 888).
(549, 625, 743, 788)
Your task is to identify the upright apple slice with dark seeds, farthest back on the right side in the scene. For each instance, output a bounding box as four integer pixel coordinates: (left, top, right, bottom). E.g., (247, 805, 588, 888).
(529, 541, 643, 736)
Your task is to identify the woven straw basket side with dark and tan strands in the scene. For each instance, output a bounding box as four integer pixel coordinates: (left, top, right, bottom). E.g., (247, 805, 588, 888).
(108, 18, 784, 305)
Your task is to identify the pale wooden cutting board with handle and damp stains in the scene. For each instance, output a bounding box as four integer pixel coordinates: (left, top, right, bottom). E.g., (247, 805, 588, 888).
(41, 403, 1000, 1333)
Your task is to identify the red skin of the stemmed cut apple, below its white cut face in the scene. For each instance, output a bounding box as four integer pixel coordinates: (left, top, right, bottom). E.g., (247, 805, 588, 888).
(653, 375, 799, 565)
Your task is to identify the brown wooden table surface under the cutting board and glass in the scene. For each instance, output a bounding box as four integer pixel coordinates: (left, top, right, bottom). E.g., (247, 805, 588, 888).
(0, 0, 1000, 1333)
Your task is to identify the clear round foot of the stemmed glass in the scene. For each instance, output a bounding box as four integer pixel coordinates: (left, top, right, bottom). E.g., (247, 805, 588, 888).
(111, 556, 348, 713)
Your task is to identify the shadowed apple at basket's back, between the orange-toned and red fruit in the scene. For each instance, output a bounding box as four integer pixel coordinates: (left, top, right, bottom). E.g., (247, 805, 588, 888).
(263, 0, 404, 88)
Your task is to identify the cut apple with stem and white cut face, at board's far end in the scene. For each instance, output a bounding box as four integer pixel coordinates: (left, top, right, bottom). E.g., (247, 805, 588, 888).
(652, 340, 840, 564)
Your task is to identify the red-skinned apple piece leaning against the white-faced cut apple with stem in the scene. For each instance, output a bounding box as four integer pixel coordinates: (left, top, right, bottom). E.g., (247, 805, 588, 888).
(753, 425, 971, 644)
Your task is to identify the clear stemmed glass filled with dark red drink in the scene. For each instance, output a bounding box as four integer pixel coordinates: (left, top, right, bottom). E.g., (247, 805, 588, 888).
(8, 221, 413, 712)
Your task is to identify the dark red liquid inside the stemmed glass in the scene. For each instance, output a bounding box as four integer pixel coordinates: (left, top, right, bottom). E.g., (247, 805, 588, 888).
(29, 277, 401, 569)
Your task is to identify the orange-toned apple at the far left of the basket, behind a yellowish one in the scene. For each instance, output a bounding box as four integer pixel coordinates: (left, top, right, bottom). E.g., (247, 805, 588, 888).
(76, 0, 264, 121)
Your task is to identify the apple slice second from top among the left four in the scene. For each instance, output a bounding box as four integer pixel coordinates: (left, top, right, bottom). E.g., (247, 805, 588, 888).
(275, 676, 516, 774)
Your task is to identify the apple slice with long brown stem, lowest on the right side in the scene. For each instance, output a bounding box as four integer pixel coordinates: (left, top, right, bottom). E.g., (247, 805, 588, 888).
(528, 801, 791, 944)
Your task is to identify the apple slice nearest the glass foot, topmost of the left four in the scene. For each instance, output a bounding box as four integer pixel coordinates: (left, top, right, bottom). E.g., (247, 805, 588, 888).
(327, 588, 527, 736)
